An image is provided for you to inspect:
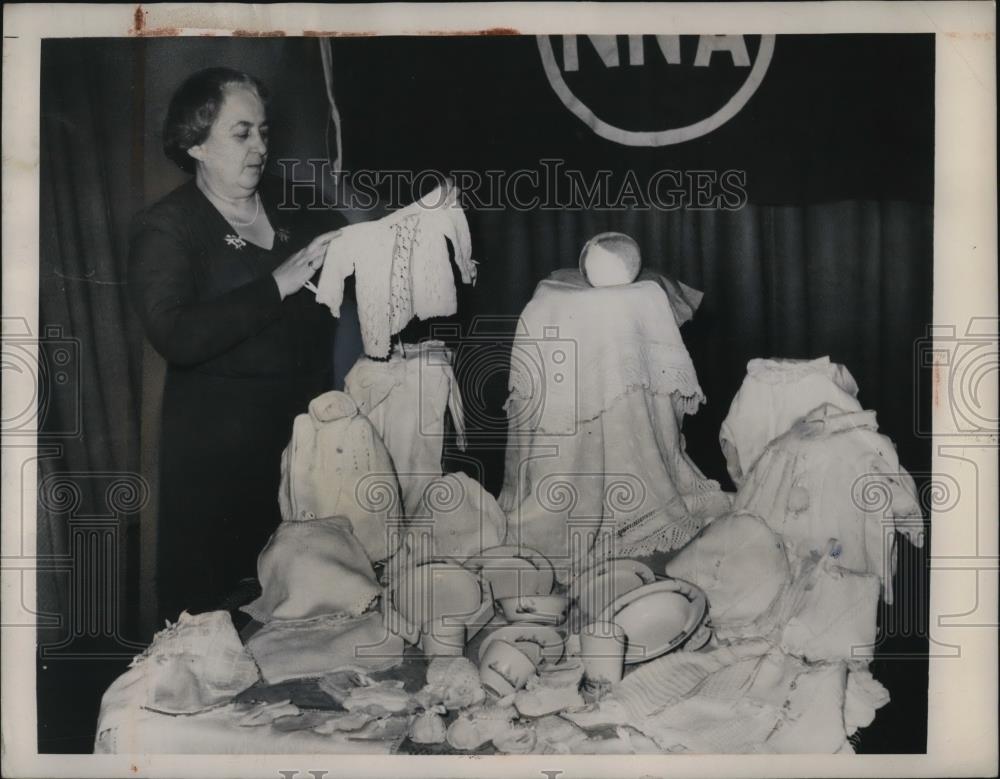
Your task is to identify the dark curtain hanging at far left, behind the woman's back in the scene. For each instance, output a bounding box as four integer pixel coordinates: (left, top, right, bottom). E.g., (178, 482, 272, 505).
(37, 41, 148, 751)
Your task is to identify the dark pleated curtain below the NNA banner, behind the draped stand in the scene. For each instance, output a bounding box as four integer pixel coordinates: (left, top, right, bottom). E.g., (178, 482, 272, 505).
(458, 201, 933, 491)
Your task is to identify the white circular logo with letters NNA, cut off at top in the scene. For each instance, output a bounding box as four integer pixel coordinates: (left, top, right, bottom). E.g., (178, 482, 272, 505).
(536, 35, 774, 146)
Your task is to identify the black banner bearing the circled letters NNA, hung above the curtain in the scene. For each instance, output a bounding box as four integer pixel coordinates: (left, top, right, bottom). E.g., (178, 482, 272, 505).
(318, 34, 934, 209)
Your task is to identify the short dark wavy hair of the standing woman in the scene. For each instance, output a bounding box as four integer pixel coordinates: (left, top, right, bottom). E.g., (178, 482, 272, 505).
(163, 68, 268, 173)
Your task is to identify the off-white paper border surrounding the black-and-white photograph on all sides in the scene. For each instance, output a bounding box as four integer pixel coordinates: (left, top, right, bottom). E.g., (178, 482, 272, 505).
(0, 2, 998, 779)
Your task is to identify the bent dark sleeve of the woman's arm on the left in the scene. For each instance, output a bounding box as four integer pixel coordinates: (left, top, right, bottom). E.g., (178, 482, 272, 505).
(128, 219, 281, 366)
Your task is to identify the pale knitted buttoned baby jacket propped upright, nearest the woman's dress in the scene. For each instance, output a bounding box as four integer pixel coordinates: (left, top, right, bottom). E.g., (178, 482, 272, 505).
(278, 391, 401, 562)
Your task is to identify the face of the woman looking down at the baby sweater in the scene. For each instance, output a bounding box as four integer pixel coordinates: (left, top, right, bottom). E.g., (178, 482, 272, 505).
(188, 85, 267, 197)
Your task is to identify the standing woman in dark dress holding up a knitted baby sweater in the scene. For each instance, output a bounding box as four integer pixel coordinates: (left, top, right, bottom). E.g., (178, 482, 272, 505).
(129, 68, 342, 620)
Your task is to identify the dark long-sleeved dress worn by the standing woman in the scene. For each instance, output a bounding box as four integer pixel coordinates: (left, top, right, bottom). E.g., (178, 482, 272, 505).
(129, 177, 341, 624)
